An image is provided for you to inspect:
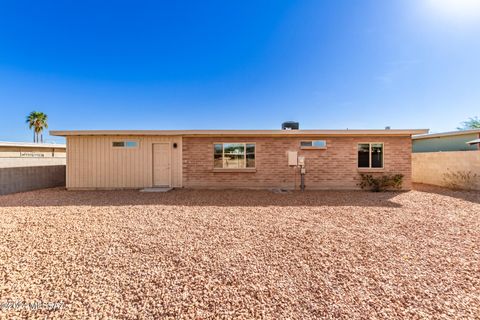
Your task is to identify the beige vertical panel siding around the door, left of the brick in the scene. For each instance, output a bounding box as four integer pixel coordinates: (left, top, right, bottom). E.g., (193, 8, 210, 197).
(66, 136, 182, 189)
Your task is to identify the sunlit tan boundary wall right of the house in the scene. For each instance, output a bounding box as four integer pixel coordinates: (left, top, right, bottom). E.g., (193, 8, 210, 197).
(412, 151, 480, 190)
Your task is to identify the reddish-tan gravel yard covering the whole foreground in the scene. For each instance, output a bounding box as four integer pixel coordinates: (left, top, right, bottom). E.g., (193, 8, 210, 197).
(0, 186, 480, 319)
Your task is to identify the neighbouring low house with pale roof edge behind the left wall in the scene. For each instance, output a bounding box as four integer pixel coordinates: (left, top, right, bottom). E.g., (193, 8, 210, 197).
(0, 141, 66, 168)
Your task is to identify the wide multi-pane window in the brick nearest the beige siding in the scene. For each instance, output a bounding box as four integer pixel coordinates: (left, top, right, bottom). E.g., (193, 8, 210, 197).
(213, 143, 255, 169)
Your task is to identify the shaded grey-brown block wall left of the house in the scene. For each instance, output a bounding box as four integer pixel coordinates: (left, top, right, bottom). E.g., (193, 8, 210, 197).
(0, 165, 65, 195)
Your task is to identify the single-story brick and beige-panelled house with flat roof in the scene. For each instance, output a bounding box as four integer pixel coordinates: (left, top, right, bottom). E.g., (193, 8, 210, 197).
(50, 129, 427, 190)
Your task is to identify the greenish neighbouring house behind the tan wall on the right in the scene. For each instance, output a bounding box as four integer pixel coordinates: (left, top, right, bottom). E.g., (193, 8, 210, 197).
(412, 129, 480, 153)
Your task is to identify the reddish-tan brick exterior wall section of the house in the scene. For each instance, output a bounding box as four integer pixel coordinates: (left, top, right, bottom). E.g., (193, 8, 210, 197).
(183, 136, 412, 190)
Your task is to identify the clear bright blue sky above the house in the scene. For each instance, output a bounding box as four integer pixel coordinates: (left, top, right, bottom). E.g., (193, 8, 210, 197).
(0, 0, 480, 141)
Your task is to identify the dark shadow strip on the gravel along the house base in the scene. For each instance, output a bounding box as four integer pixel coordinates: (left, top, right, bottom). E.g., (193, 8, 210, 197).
(0, 188, 402, 208)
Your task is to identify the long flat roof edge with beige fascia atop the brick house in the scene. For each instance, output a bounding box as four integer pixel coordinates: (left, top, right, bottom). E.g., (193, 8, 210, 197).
(50, 129, 428, 137)
